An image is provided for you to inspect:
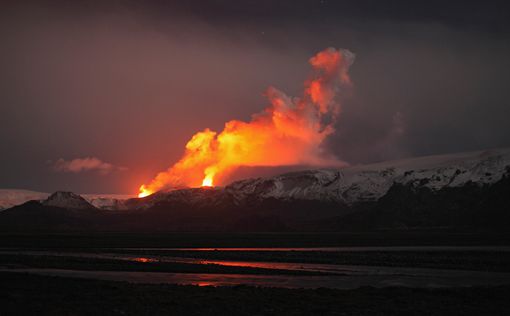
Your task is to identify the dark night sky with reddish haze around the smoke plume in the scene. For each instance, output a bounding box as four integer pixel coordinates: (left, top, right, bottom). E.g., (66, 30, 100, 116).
(0, 0, 510, 193)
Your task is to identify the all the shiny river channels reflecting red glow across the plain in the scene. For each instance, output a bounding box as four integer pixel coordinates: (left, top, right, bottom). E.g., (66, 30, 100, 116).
(0, 247, 510, 289)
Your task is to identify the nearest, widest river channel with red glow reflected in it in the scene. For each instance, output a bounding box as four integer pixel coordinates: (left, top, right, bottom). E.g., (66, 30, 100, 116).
(0, 269, 510, 289)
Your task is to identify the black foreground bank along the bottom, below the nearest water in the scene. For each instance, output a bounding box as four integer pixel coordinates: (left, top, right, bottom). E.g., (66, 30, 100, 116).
(0, 272, 510, 315)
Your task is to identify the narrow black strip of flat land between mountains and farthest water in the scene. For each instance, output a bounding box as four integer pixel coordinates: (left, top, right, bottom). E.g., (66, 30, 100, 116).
(0, 230, 510, 249)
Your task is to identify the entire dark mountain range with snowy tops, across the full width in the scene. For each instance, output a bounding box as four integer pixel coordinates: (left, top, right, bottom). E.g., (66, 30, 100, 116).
(0, 148, 510, 231)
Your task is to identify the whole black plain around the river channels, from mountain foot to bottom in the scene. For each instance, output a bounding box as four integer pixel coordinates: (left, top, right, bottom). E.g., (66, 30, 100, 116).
(0, 231, 510, 316)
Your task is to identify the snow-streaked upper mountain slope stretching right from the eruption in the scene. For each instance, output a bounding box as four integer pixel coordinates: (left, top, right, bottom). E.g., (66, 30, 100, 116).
(137, 148, 510, 208)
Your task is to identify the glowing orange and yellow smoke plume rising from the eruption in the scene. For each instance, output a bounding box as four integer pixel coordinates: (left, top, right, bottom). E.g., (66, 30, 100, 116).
(139, 48, 354, 197)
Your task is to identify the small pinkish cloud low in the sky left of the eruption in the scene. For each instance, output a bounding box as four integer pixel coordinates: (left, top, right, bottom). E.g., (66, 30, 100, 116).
(53, 157, 126, 174)
